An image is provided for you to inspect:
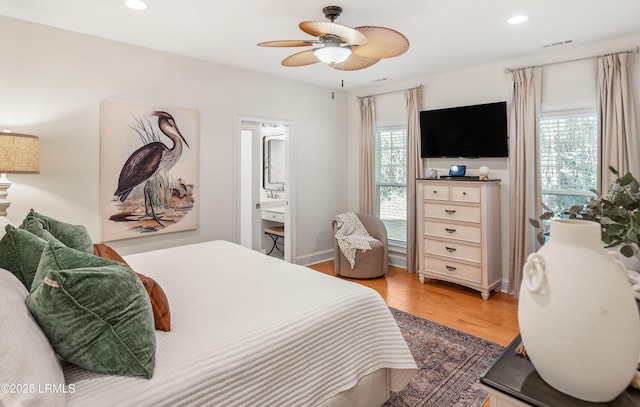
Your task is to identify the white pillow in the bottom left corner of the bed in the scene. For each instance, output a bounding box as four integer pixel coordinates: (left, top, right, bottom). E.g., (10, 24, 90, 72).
(0, 270, 66, 407)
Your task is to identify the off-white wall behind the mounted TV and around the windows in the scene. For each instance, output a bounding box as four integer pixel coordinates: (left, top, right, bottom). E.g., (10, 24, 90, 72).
(348, 34, 640, 287)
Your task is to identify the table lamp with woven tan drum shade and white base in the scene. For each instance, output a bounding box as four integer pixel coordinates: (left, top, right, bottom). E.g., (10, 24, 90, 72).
(0, 131, 40, 216)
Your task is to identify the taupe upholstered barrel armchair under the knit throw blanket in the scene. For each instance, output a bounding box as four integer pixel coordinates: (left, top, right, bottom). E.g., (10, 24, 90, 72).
(333, 213, 389, 279)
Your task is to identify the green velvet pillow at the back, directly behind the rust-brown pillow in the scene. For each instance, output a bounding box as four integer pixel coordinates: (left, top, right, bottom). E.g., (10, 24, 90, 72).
(20, 209, 93, 253)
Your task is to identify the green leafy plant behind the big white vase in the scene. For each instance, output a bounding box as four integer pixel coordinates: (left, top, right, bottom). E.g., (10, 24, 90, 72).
(529, 167, 640, 257)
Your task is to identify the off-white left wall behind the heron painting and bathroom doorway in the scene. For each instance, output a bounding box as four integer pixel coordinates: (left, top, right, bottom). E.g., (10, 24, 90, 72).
(0, 17, 347, 262)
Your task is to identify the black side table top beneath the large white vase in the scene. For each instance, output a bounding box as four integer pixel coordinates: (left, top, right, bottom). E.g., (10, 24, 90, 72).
(480, 335, 640, 407)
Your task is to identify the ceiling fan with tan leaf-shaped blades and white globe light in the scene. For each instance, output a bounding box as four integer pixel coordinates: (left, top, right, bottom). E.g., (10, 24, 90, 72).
(258, 6, 409, 71)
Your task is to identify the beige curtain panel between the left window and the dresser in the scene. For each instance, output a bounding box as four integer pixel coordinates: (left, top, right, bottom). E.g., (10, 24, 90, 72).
(406, 86, 422, 273)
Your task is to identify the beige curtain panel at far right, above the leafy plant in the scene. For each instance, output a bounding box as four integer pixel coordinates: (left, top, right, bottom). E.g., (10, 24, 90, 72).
(597, 52, 640, 192)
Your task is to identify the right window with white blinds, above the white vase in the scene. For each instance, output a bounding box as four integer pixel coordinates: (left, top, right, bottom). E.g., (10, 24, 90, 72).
(540, 109, 598, 213)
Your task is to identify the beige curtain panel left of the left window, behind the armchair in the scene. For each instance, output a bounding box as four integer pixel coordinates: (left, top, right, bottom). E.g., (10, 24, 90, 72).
(359, 96, 376, 215)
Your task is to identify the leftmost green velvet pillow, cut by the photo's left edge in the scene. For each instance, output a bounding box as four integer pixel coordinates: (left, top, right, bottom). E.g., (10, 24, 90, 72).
(0, 225, 47, 290)
